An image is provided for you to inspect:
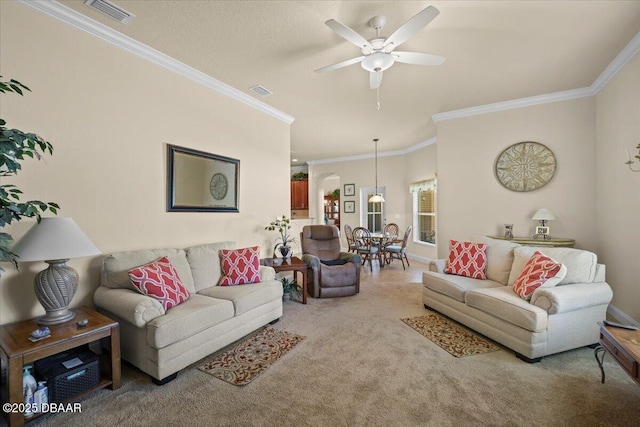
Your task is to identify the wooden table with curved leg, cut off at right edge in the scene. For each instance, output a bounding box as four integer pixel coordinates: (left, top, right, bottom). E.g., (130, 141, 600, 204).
(595, 323, 640, 385)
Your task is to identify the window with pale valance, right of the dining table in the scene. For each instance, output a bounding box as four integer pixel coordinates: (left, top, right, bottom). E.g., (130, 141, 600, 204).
(409, 178, 437, 245)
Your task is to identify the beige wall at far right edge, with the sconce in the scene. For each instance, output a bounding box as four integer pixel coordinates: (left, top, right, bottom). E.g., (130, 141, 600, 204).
(595, 55, 640, 322)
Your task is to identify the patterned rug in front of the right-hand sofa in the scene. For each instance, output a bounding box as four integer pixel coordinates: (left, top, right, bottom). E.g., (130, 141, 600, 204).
(402, 313, 500, 357)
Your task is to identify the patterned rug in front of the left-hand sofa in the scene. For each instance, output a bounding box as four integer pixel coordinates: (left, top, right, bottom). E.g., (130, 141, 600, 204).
(198, 328, 305, 386)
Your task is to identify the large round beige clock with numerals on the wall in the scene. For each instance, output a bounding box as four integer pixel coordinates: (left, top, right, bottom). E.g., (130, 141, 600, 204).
(495, 141, 556, 192)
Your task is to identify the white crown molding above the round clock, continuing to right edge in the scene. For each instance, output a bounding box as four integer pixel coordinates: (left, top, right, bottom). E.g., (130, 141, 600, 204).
(431, 32, 640, 124)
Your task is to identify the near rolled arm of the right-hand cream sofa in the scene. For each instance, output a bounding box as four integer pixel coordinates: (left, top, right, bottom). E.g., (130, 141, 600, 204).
(531, 282, 613, 314)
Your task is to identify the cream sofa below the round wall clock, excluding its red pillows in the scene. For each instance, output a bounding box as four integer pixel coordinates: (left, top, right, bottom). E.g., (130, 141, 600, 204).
(422, 237, 613, 363)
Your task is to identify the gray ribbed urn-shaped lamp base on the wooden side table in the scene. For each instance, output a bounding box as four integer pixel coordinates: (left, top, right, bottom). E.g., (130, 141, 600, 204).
(33, 259, 78, 325)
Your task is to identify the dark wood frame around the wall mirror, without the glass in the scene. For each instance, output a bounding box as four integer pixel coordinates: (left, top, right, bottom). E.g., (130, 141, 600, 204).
(167, 144, 240, 212)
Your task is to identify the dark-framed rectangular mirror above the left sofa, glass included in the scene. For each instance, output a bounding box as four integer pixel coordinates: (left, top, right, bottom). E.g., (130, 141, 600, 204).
(167, 144, 240, 212)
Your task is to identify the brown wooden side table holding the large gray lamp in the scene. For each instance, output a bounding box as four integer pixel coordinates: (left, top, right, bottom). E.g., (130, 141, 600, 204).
(0, 307, 121, 426)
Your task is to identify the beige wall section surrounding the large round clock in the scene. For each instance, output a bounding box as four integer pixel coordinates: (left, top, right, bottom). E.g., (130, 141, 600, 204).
(438, 97, 597, 257)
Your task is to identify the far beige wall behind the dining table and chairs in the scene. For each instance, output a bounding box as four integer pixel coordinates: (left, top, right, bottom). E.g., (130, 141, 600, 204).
(309, 145, 436, 259)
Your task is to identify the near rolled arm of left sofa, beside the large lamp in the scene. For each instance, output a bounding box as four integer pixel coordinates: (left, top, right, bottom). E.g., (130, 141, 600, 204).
(93, 286, 165, 328)
